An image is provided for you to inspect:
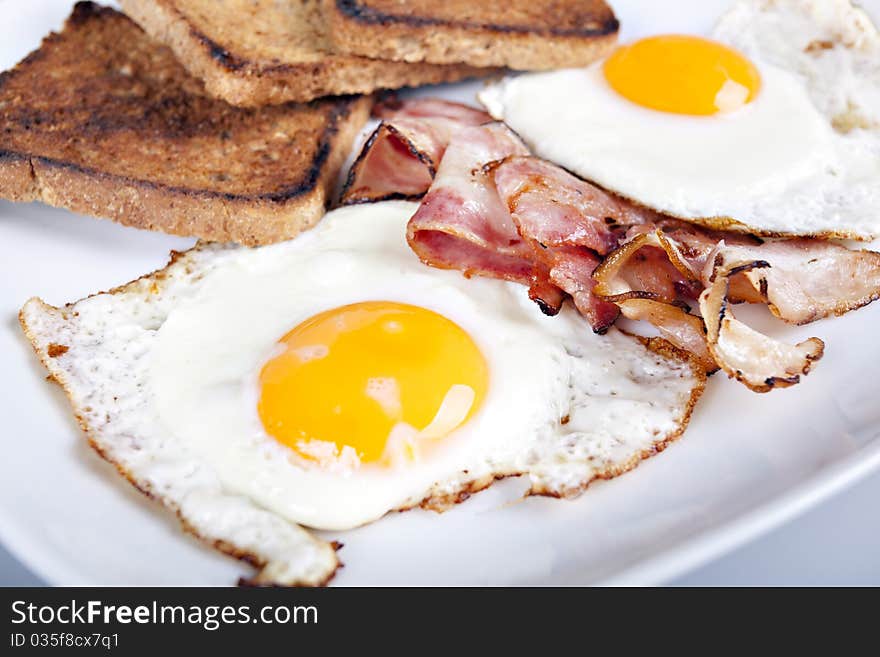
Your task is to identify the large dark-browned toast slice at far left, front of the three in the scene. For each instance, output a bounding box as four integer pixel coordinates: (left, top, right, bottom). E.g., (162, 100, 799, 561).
(0, 2, 371, 245)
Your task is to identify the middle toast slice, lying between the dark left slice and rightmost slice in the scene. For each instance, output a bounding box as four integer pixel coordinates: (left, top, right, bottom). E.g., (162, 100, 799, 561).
(121, 0, 487, 107)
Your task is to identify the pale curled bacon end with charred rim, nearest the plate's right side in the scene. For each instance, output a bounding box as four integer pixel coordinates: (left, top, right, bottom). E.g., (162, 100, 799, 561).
(700, 262, 825, 392)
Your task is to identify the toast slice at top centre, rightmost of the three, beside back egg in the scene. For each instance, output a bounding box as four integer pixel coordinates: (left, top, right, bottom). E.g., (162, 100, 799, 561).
(323, 0, 619, 70)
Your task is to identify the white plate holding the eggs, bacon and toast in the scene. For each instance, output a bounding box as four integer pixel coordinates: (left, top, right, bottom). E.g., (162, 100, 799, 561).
(0, 0, 880, 585)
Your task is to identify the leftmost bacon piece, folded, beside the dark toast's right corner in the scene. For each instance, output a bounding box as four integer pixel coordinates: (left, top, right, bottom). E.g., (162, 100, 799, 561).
(341, 99, 492, 205)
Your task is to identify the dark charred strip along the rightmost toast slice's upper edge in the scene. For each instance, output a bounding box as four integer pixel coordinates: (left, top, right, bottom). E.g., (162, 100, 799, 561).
(336, 0, 620, 37)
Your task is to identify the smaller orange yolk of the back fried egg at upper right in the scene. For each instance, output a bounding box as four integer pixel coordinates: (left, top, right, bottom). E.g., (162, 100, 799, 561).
(604, 35, 761, 116)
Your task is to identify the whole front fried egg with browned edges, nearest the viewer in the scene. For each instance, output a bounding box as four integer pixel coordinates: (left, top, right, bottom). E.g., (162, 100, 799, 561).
(21, 202, 705, 584)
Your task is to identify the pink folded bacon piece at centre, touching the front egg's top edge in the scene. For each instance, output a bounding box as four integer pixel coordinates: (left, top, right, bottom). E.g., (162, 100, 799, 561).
(407, 123, 534, 285)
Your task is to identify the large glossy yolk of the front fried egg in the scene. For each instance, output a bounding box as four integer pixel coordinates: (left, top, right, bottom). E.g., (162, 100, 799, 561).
(258, 301, 489, 465)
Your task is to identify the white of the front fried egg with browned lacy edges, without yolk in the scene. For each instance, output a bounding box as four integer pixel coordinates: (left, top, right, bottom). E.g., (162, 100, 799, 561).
(20, 203, 705, 585)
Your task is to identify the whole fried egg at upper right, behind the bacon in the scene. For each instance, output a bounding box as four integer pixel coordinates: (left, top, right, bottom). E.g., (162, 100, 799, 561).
(480, 0, 880, 240)
